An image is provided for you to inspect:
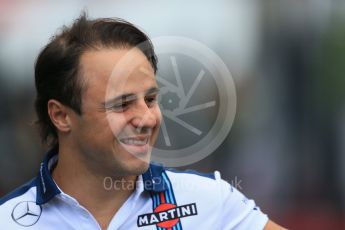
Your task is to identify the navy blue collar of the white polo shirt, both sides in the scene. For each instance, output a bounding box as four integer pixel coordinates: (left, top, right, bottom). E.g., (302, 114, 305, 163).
(36, 146, 168, 205)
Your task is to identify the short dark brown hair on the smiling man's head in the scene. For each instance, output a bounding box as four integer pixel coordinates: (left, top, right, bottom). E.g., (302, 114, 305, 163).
(35, 13, 157, 145)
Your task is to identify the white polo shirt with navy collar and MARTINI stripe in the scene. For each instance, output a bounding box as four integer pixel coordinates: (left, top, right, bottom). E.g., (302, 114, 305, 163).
(0, 149, 268, 230)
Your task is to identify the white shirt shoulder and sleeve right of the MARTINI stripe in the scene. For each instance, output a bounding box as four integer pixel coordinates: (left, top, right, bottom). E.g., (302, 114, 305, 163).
(166, 170, 268, 229)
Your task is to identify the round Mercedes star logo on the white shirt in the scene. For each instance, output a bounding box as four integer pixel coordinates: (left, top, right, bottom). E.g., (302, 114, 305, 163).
(12, 201, 42, 227)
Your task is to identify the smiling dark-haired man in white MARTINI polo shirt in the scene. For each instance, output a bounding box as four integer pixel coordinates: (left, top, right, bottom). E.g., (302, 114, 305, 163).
(0, 15, 281, 230)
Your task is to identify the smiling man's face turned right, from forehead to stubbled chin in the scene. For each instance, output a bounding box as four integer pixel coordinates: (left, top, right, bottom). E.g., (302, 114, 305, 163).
(71, 48, 161, 176)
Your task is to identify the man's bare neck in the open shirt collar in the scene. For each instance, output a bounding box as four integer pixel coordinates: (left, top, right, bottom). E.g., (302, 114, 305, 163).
(52, 149, 137, 229)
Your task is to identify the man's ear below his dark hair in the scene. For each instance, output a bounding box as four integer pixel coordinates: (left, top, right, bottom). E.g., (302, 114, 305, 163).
(48, 99, 71, 132)
